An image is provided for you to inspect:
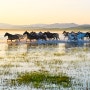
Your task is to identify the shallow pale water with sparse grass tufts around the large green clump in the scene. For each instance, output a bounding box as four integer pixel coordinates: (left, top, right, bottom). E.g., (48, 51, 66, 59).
(0, 31, 90, 90)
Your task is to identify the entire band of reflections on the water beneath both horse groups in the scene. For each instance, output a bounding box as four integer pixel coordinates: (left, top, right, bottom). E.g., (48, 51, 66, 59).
(5, 42, 90, 55)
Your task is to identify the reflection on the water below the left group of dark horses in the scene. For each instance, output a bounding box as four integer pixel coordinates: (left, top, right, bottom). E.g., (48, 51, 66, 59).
(5, 42, 59, 55)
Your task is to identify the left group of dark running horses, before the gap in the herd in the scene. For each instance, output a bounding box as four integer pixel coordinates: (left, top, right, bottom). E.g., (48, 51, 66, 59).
(4, 31, 60, 41)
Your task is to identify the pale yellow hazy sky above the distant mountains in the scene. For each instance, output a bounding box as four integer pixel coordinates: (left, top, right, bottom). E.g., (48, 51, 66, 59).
(0, 0, 90, 25)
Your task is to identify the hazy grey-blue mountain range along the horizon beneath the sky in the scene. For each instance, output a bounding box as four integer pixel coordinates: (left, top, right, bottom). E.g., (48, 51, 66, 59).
(0, 23, 90, 29)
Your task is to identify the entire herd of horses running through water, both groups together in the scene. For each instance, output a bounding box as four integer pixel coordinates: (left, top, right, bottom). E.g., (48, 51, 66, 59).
(4, 31, 90, 42)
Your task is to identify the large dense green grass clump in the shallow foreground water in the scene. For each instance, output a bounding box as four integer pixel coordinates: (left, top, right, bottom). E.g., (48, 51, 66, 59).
(10, 71, 71, 88)
